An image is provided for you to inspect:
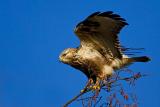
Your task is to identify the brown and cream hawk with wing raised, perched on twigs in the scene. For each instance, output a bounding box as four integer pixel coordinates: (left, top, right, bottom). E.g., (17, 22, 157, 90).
(59, 11, 150, 87)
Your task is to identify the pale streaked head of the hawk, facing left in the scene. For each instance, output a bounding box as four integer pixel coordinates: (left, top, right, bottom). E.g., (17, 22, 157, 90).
(59, 48, 76, 64)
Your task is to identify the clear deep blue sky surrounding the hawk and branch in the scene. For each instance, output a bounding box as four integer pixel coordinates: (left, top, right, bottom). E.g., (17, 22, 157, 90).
(0, 0, 160, 107)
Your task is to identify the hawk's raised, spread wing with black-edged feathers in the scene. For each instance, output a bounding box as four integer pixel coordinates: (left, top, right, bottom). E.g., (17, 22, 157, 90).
(75, 11, 127, 59)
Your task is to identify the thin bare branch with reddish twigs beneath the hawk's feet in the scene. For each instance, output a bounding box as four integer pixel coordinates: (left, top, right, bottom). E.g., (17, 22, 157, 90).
(63, 71, 147, 107)
